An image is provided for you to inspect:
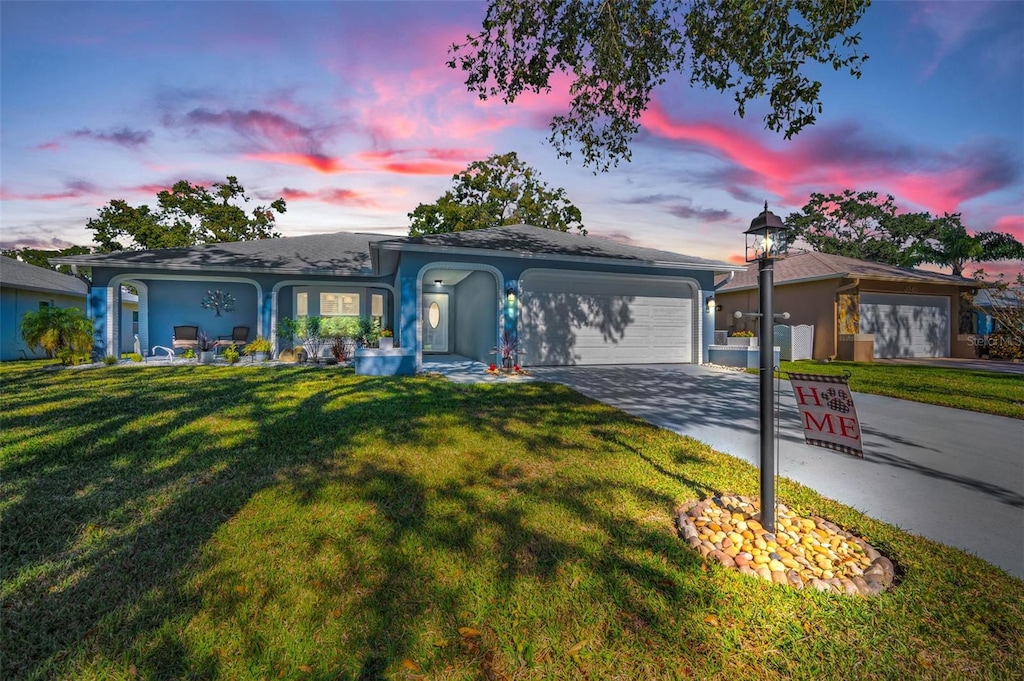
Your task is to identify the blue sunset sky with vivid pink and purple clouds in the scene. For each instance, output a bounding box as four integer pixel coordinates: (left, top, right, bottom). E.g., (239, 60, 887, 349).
(0, 0, 1024, 268)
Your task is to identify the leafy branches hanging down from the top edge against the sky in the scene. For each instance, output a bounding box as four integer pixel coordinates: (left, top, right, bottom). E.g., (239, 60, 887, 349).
(449, 0, 869, 170)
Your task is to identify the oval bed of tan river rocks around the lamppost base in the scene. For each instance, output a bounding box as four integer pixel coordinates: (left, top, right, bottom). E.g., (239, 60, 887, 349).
(677, 496, 894, 596)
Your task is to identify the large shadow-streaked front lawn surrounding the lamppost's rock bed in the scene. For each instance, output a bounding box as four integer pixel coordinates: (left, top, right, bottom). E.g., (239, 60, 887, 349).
(0, 364, 1024, 679)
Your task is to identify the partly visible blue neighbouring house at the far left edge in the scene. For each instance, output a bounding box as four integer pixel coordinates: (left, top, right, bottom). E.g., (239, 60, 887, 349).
(0, 256, 89, 360)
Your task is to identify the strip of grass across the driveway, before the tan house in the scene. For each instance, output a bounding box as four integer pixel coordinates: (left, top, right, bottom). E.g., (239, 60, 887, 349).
(774, 359, 1024, 419)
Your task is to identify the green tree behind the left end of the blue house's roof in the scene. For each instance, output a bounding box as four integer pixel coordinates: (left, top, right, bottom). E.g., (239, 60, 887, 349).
(86, 175, 286, 253)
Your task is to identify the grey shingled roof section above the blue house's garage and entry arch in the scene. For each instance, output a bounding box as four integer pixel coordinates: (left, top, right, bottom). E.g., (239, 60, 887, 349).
(377, 224, 736, 271)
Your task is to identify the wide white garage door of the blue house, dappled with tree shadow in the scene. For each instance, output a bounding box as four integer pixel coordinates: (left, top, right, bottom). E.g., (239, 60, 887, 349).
(519, 269, 698, 367)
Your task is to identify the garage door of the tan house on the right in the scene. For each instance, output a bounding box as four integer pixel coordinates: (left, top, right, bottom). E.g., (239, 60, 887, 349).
(860, 293, 949, 357)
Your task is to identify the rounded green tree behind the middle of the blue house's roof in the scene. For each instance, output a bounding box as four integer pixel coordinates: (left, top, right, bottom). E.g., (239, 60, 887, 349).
(409, 152, 587, 237)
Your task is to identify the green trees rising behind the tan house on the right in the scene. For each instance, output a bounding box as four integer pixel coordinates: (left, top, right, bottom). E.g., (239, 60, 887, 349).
(785, 189, 1024, 276)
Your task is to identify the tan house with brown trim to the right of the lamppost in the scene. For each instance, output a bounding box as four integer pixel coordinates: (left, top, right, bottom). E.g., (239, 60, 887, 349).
(715, 252, 978, 359)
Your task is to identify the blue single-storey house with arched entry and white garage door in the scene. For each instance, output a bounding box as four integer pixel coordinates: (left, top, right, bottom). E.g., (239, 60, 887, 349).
(55, 225, 741, 373)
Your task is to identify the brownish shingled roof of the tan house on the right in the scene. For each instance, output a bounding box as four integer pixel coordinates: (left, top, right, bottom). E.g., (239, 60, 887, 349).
(719, 251, 978, 292)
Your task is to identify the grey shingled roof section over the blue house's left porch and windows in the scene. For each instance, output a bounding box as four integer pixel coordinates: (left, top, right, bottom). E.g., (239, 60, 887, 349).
(51, 231, 388, 276)
